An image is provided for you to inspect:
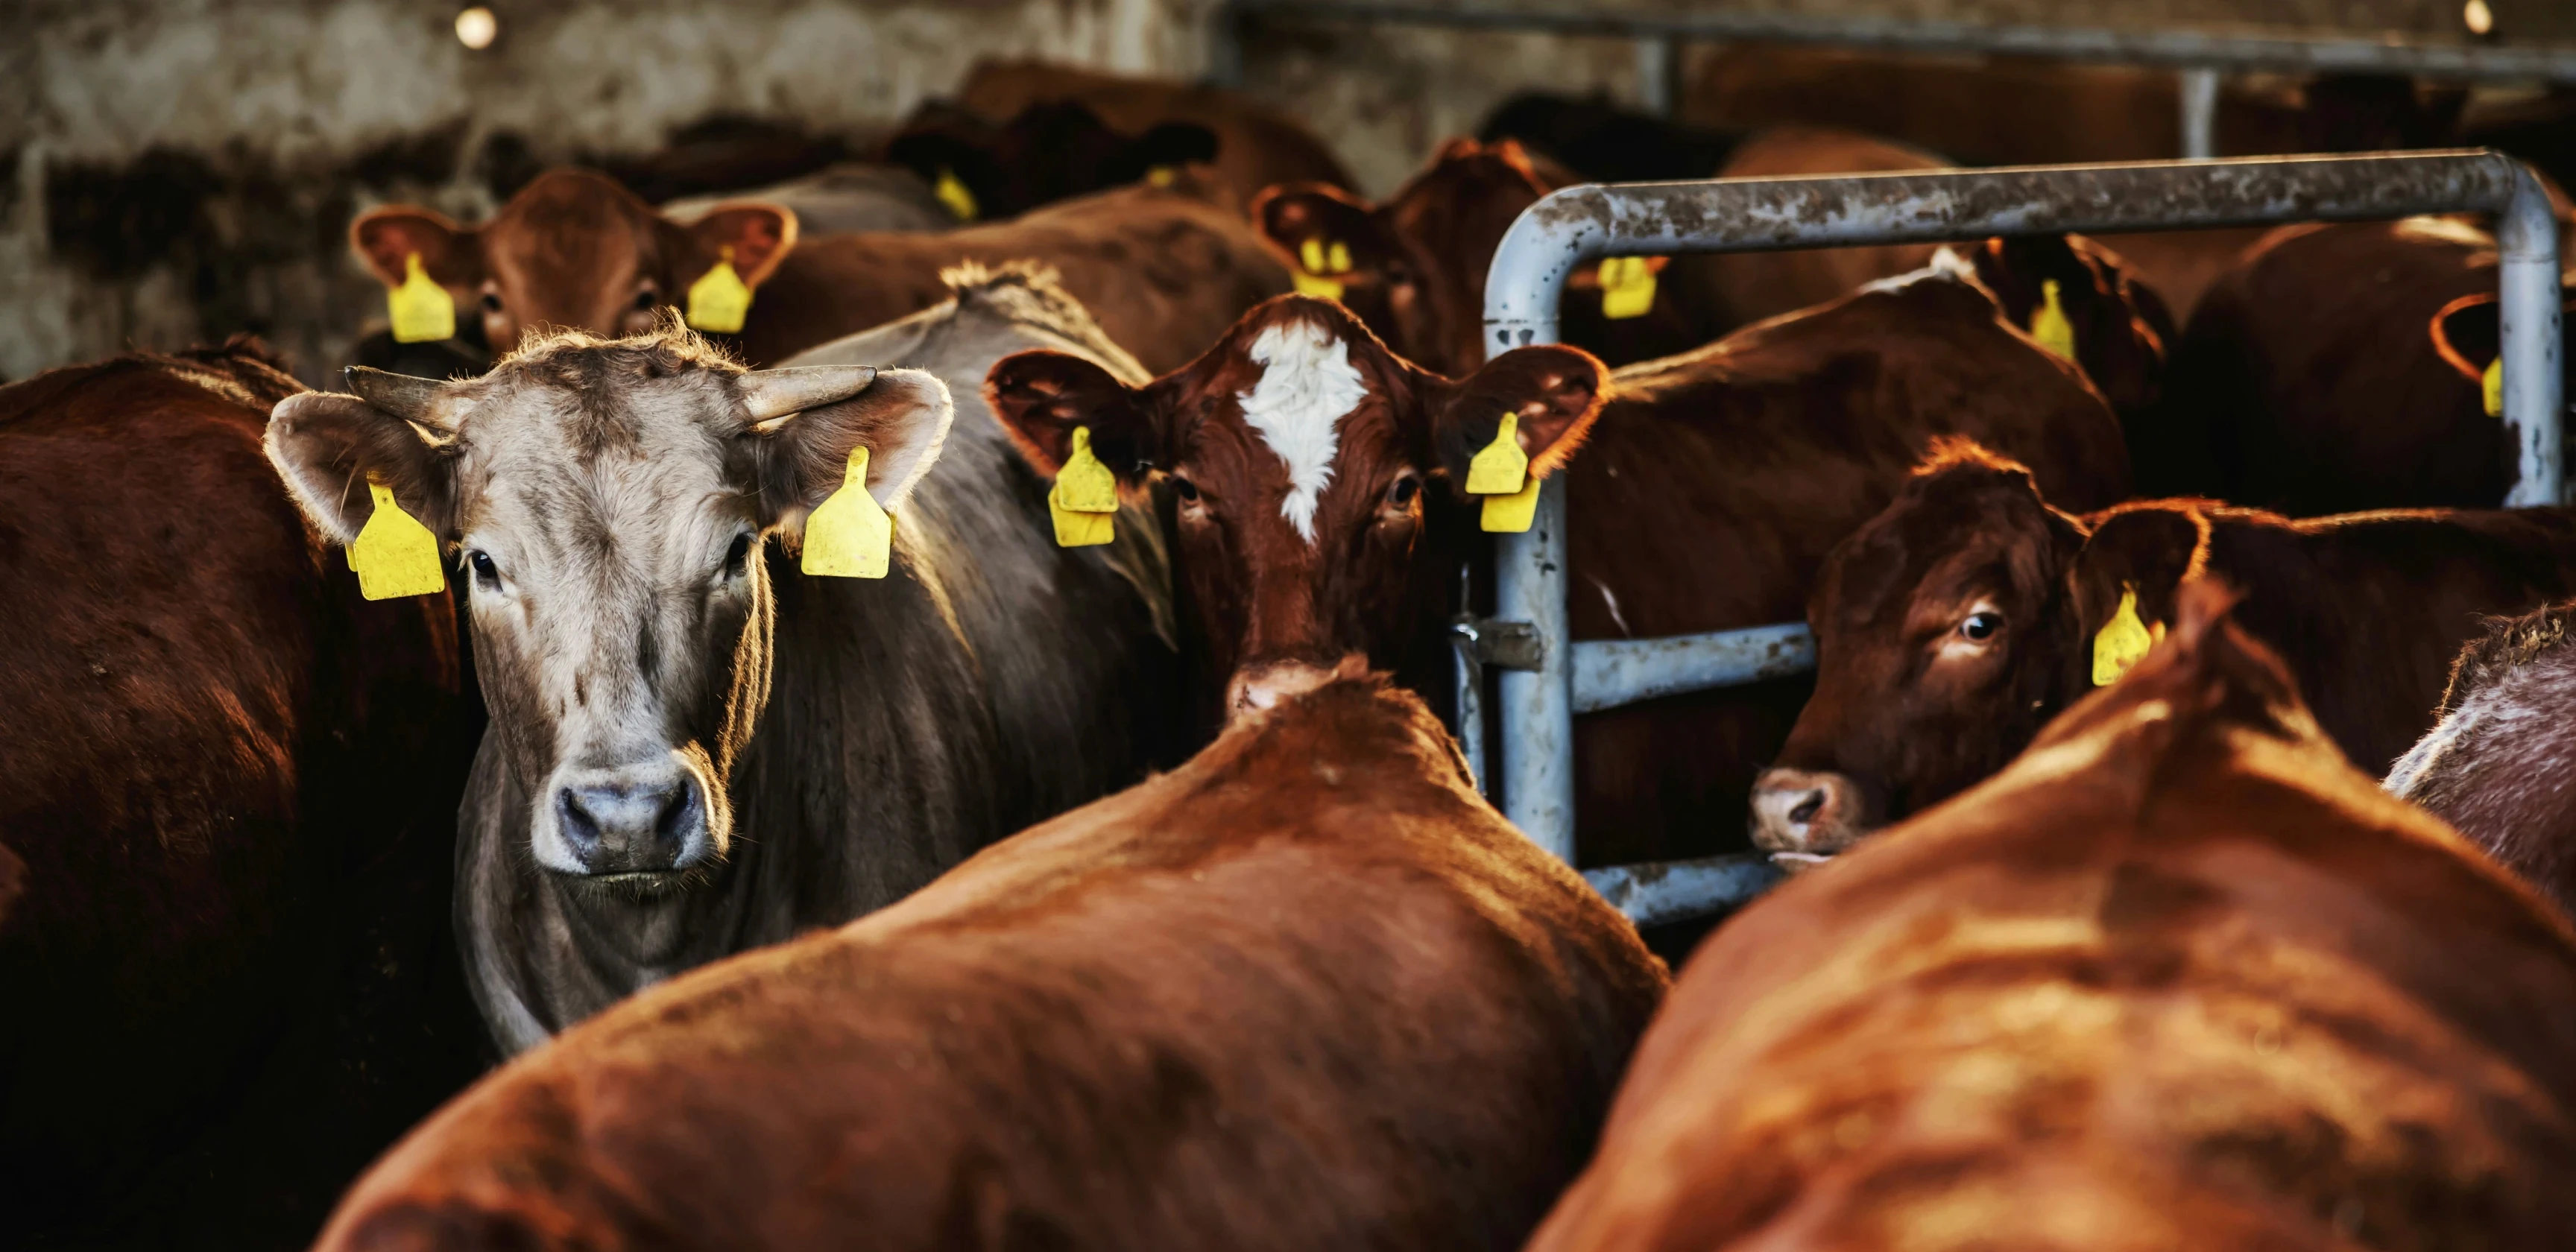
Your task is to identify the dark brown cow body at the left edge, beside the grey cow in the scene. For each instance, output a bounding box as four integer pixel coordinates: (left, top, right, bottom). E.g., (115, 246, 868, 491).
(0, 338, 482, 1250)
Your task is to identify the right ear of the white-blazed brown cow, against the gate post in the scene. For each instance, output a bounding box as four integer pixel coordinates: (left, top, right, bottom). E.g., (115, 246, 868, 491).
(1430, 343, 1610, 492)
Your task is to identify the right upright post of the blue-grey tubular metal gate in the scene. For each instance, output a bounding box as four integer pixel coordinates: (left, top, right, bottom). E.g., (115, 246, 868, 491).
(2496, 168, 2566, 508)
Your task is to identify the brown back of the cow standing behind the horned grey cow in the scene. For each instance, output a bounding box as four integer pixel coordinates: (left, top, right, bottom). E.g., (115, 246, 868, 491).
(736, 178, 1288, 373)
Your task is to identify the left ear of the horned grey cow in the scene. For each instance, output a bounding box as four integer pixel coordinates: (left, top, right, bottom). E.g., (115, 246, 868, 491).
(260, 391, 456, 543)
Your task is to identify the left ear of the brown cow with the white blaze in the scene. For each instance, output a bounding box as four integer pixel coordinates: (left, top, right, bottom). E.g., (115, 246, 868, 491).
(984, 350, 1172, 487)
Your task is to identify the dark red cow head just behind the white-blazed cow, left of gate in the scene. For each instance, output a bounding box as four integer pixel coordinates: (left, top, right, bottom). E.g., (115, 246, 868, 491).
(1252, 139, 1548, 373)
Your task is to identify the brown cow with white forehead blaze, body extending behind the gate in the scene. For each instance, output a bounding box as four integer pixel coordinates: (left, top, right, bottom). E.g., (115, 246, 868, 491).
(987, 271, 2128, 863)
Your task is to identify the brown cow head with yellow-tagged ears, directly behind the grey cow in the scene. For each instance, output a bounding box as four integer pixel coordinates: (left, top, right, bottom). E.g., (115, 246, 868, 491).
(348, 170, 796, 353)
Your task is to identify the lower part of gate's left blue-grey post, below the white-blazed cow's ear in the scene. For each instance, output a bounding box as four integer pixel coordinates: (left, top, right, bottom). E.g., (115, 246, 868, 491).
(1494, 478, 1574, 865)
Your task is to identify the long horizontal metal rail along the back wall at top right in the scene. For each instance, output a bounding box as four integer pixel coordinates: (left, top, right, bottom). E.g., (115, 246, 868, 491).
(1231, 0, 2576, 83)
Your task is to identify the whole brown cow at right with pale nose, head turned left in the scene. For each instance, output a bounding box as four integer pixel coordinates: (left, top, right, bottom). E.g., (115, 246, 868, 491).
(1752, 443, 2576, 861)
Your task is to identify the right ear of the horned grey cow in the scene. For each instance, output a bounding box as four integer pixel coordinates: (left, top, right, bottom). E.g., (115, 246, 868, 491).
(739, 366, 956, 534)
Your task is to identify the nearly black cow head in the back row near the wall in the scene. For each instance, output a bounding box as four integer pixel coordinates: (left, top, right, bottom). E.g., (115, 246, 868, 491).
(886, 101, 1216, 219)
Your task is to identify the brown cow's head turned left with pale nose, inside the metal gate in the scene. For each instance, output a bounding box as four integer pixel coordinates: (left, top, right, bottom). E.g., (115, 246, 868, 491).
(1752, 440, 2084, 865)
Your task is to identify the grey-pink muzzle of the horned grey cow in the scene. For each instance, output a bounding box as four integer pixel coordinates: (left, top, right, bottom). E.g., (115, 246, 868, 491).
(536, 757, 716, 879)
